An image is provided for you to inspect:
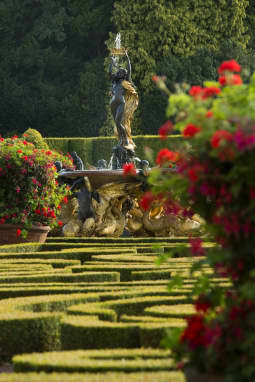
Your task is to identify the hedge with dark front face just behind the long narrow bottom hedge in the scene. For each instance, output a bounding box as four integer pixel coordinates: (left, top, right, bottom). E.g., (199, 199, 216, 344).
(61, 316, 184, 350)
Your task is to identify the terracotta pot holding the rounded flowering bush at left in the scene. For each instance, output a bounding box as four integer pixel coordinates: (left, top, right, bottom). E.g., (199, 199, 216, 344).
(0, 224, 50, 245)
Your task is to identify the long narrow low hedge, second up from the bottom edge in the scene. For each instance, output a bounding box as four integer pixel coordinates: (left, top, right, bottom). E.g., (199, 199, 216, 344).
(13, 348, 172, 373)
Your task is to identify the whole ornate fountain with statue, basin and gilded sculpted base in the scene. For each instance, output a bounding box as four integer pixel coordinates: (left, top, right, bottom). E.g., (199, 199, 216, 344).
(56, 34, 203, 237)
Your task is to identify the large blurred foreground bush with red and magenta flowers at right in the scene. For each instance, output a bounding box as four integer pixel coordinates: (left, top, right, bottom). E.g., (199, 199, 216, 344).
(150, 60, 255, 382)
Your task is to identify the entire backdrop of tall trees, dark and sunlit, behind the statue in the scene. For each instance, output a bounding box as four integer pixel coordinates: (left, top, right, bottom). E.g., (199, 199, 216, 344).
(0, 0, 255, 137)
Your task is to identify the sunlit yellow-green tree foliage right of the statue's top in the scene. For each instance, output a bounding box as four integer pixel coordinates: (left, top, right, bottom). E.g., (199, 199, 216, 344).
(112, 0, 249, 90)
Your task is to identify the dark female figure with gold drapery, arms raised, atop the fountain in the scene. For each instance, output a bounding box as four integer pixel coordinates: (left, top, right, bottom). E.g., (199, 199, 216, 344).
(109, 51, 138, 156)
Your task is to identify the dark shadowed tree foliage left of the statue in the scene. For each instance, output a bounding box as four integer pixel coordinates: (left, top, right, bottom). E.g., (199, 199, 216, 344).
(0, 0, 113, 136)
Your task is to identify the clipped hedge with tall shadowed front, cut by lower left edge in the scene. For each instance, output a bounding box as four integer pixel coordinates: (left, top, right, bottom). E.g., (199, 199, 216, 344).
(0, 294, 98, 360)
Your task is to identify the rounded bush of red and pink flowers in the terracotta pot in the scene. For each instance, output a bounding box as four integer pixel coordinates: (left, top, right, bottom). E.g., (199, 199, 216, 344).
(0, 136, 73, 237)
